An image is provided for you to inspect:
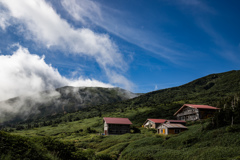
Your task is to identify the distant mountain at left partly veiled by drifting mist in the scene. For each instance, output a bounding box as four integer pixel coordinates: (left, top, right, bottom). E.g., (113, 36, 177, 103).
(0, 86, 137, 122)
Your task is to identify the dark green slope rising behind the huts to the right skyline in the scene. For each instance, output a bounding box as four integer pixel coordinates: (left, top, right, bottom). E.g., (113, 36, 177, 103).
(87, 71, 240, 125)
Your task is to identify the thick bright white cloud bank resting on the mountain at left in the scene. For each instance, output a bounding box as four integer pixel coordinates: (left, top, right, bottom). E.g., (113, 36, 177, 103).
(0, 46, 113, 100)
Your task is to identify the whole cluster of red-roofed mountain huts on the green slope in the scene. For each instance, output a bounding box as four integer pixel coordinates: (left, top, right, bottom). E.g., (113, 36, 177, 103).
(103, 104, 219, 135)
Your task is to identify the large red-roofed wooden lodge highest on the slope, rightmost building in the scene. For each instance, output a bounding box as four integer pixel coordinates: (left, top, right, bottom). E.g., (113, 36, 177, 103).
(174, 104, 219, 121)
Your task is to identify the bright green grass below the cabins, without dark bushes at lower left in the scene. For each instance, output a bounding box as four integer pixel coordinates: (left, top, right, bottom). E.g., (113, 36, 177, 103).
(4, 115, 240, 160)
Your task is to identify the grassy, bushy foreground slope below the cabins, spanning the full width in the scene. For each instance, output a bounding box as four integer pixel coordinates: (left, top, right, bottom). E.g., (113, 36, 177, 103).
(0, 118, 240, 160)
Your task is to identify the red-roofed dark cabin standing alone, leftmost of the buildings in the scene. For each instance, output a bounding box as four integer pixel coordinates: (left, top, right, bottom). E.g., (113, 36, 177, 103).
(103, 117, 132, 135)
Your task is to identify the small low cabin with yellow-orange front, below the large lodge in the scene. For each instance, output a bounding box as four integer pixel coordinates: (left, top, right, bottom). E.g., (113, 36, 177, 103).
(157, 123, 187, 135)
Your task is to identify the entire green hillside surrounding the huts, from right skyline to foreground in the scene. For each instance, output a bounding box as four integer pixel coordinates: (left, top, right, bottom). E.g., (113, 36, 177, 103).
(0, 71, 240, 160)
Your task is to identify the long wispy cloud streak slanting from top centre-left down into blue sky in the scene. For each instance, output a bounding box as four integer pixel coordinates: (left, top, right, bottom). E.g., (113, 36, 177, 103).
(62, 0, 188, 63)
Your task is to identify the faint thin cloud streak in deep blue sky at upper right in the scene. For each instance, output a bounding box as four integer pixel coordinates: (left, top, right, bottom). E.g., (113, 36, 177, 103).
(178, 0, 240, 63)
